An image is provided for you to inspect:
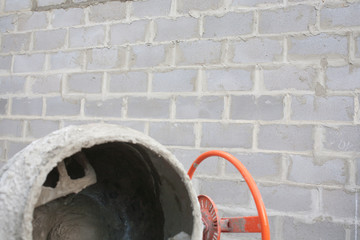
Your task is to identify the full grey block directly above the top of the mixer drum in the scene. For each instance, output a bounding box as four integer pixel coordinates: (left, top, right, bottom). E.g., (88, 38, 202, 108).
(85, 98, 122, 117)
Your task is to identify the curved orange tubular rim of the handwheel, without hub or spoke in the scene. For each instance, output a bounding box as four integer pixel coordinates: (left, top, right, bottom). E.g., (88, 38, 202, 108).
(188, 150, 270, 240)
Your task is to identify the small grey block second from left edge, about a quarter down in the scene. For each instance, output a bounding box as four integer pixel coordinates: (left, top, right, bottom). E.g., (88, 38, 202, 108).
(14, 54, 45, 72)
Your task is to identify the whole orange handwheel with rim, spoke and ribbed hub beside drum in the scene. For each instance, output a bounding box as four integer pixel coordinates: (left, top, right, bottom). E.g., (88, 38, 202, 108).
(188, 150, 270, 240)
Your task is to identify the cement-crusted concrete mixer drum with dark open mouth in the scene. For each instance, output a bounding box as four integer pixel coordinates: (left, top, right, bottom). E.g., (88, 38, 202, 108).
(0, 124, 202, 240)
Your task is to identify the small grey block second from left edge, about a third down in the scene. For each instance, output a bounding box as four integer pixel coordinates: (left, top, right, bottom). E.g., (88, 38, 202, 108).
(30, 74, 62, 94)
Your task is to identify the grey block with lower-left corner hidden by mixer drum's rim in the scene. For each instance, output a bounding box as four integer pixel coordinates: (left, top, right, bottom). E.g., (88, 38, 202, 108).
(149, 122, 195, 146)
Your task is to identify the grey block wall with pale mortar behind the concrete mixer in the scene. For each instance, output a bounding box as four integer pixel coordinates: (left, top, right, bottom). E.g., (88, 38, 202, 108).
(0, 0, 360, 240)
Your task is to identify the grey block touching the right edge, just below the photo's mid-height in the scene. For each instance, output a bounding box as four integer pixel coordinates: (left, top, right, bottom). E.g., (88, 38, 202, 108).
(324, 125, 360, 152)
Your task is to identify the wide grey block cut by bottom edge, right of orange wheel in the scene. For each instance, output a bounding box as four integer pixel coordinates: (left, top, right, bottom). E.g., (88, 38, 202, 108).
(282, 217, 345, 240)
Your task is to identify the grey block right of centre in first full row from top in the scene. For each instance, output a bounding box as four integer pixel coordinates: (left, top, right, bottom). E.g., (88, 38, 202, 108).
(204, 12, 254, 38)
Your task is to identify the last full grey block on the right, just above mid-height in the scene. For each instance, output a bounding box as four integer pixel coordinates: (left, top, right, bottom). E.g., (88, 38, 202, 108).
(291, 95, 354, 121)
